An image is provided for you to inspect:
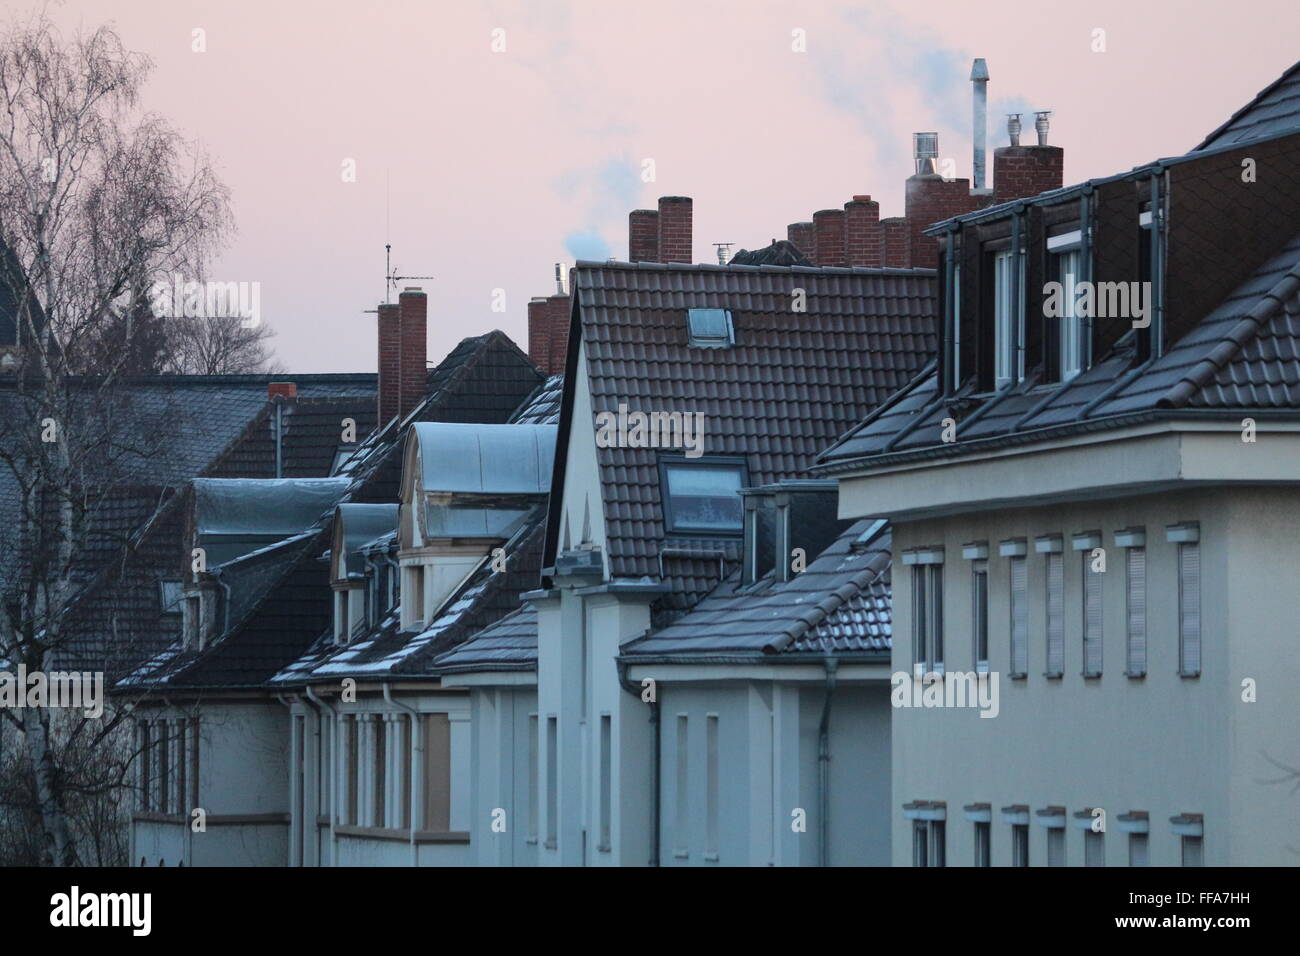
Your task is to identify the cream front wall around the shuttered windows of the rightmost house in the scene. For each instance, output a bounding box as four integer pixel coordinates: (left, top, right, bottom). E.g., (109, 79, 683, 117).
(891, 490, 1232, 866)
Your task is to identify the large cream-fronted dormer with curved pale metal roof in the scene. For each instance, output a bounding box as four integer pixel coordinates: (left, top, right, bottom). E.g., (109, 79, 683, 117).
(398, 421, 555, 628)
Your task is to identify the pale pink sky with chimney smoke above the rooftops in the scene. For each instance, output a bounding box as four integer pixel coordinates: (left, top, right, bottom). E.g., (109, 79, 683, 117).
(35, 0, 1300, 372)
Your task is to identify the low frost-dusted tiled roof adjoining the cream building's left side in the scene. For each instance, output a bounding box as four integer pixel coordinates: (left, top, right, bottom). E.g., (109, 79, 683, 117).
(621, 519, 891, 662)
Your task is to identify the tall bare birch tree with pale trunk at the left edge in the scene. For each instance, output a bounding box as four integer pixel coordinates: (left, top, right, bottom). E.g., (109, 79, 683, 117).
(0, 13, 230, 865)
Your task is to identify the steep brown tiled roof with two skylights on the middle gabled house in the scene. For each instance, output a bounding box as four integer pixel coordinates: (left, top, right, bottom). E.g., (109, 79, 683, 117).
(559, 261, 936, 617)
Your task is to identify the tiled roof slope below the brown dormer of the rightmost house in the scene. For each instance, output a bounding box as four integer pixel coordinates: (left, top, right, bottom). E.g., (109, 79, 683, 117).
(819, 235, 1300, 471)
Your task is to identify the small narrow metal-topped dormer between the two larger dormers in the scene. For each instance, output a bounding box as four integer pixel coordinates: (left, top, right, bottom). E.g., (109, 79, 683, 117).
(329, 505, 398, 644)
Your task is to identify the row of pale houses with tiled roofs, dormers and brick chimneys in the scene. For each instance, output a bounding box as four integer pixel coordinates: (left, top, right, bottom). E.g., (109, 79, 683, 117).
(27, 57, 1300, 866)
